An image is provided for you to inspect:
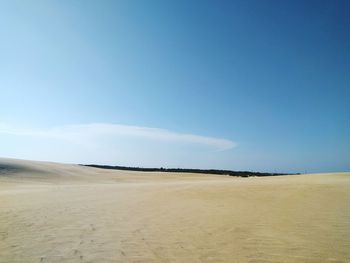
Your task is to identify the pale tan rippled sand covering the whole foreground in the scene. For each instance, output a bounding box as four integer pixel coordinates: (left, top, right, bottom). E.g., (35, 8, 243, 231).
(0, 159, 350, 263)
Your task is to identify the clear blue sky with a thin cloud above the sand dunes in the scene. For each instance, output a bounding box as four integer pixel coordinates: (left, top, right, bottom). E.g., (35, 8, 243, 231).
(0, 0, 350, 172)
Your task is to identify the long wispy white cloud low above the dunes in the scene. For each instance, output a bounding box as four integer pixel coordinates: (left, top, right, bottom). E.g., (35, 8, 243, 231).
(0, 123, 237, 151)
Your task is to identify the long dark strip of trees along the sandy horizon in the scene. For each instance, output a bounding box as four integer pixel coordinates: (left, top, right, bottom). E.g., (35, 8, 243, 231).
(83, 164, 298, 177)
